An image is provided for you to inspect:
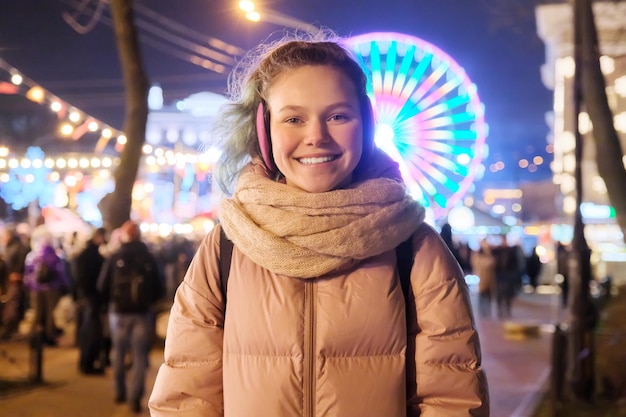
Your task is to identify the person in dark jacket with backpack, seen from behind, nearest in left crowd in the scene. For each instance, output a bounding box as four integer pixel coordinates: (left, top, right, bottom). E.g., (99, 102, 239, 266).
(97, 220, 162, 413)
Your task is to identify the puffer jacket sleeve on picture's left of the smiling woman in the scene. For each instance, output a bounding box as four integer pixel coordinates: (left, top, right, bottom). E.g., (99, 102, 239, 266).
(149, 227, 224, 417)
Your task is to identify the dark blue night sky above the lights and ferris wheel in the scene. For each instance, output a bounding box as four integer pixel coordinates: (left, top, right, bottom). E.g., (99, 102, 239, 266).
(0, 0, 552, 184)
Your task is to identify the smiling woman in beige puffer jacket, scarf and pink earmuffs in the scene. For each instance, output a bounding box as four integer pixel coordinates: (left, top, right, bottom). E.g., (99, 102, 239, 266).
(149, 38, 489, 417)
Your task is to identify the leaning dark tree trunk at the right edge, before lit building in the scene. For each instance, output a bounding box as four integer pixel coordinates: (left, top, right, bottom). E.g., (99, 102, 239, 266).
(578, 0, 626, 241)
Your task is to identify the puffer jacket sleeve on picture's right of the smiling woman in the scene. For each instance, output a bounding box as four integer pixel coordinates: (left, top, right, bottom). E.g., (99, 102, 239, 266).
(407, 224, 489, 417)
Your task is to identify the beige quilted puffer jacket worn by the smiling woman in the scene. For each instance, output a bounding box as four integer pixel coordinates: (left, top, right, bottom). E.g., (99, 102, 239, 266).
(149, 224, 489, 417)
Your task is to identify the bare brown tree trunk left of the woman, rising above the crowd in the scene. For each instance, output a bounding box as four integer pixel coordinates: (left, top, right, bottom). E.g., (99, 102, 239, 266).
(99, 0, 149, 230)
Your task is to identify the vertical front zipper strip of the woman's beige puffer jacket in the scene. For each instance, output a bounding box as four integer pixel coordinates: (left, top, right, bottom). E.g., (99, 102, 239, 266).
(303, 279, 315, 417)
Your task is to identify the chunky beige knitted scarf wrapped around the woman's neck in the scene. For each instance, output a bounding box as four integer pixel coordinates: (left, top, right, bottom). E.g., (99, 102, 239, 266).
(220, 152, 424, 278)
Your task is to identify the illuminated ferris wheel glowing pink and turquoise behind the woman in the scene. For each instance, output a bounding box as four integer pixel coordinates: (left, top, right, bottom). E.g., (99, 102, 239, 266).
(346, 32, 488, 218)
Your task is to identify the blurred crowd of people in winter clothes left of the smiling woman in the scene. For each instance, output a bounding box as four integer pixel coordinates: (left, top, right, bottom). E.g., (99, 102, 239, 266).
(0, 218, 198, 412)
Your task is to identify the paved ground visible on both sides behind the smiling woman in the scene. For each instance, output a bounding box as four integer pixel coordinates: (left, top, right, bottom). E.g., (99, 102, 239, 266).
(0, 288, 556, 417)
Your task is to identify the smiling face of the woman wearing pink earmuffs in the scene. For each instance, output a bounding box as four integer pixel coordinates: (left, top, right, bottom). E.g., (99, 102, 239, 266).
(267, 65, 363, 193)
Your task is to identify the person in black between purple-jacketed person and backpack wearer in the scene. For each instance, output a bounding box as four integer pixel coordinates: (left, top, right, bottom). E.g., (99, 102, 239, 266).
(75, 228, 108, 374)
